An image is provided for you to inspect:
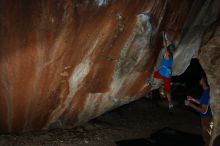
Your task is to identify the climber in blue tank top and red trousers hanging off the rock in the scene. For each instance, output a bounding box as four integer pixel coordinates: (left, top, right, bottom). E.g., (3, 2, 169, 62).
(151, 33, 175, 110)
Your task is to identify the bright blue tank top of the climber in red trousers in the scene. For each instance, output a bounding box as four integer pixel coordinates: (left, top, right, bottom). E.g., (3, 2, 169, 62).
(159, 57, 173, 78)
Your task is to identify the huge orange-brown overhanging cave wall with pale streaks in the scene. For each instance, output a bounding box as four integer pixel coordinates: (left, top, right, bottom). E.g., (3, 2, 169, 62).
(0, 0, 219, 137)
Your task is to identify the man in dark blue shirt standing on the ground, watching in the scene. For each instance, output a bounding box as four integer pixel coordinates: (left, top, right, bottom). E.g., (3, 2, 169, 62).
(185, 77, 213, 146)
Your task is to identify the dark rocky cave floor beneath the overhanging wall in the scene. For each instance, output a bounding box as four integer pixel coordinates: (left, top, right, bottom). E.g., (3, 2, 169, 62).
(0, 85, 201, 146)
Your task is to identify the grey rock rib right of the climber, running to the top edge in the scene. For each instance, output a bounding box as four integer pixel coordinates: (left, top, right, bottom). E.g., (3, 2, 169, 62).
(173, 0, 220, 75)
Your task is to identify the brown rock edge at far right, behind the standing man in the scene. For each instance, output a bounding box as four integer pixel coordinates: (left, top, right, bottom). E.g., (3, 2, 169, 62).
(199, 21, 220, 145)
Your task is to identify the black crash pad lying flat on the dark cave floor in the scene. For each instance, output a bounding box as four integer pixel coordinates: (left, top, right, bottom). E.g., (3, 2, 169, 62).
(116, 127, 204, 146)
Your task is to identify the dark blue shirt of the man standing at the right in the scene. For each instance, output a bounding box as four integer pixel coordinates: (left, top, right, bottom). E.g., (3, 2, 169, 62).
(200, 89, 212, 118)
